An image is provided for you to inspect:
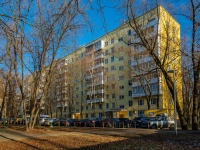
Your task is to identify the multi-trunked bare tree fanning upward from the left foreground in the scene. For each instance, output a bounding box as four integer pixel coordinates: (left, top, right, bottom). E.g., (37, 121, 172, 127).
(0, 0, 87, 130)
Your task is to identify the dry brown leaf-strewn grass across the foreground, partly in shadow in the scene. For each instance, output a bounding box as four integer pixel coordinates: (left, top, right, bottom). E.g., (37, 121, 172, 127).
(0, 127, 200, 150)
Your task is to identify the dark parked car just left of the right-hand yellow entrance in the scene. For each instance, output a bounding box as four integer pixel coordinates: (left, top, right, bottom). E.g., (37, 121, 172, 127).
(101, 118, 121, 127)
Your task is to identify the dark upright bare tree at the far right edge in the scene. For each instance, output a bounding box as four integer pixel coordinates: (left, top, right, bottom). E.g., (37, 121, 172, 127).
(178, 0, 200, 130)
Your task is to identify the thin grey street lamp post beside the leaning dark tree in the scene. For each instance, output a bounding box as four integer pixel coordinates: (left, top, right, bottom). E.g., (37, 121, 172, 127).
(168, 70, 177, 135)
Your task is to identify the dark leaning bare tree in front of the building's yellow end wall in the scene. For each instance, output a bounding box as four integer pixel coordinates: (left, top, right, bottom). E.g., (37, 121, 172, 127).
(119, 0, 187, 129)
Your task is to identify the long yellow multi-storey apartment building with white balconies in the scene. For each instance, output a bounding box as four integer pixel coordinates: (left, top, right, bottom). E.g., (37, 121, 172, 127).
(34, 6, 182, 119)
